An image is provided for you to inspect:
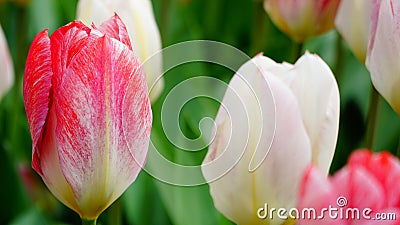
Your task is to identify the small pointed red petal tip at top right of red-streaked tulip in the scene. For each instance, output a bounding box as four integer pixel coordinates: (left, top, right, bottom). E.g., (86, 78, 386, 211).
(96, 14, 132, 50)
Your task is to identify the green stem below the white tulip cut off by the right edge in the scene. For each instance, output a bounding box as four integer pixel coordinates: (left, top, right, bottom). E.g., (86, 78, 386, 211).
(365, 86, 379, 149)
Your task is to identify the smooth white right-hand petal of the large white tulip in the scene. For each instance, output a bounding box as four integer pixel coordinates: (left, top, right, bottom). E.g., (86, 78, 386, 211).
(278, 52, 340, 174)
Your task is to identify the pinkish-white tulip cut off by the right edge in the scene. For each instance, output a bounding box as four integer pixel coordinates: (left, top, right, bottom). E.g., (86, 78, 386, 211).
(366, 0, 400, 114)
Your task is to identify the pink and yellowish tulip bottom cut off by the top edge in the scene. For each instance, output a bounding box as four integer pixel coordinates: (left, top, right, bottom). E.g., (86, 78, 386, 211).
(264, 0, 340, 42)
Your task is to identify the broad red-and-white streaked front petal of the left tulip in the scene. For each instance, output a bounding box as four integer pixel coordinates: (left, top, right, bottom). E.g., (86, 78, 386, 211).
(56, 36, 151, 218)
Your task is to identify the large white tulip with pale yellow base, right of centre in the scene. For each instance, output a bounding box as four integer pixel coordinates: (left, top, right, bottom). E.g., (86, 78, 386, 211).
(202, 52, 339, 225)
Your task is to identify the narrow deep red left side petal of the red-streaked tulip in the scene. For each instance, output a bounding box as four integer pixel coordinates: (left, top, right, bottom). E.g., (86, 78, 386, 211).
(23, 30, 53, 174)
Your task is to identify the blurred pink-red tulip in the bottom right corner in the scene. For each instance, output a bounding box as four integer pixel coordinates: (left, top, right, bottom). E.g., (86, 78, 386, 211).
(298, 150, 400, 225)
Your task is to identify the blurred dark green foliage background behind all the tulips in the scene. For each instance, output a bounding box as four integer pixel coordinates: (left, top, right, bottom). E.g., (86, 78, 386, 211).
(0, 0, 400, 225)
